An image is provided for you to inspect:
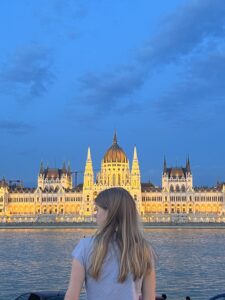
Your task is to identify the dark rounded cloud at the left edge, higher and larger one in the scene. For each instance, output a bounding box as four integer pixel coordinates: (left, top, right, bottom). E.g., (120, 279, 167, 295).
(0, 45, 55, 99)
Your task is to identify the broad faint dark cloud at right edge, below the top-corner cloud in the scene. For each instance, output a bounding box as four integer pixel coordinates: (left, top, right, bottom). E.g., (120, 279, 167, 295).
(156, 51, 225, 119)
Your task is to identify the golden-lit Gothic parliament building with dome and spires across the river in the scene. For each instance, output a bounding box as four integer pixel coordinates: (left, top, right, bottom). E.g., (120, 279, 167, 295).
(0, 133, 225, 223)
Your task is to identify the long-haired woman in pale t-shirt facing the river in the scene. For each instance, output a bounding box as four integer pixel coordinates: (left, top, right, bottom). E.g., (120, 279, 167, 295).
(65, 188, 155, 300)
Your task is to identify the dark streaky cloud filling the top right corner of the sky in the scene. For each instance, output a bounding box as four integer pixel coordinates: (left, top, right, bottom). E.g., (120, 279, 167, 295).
(138, 0, 225, 66)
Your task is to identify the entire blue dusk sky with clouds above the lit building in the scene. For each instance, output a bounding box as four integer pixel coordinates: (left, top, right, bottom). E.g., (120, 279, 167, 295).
(0, 0, 225, 186)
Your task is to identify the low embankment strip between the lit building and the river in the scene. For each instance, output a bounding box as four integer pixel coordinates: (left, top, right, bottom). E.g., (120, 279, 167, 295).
(0, 222, 225, 230)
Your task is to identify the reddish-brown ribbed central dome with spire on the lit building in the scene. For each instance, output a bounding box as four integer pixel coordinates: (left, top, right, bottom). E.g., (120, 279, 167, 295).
(103, 133, 128, 163)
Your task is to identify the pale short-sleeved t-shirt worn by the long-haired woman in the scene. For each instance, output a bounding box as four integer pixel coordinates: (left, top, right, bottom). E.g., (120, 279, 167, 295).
(72, 237, 142, 300)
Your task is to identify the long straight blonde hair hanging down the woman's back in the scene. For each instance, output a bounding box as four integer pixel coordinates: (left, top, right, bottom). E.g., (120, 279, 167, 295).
(89, 188, 153, 283)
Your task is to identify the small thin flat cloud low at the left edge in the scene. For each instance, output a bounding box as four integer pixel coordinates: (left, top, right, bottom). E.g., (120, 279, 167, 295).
(0, 120, 34, 135)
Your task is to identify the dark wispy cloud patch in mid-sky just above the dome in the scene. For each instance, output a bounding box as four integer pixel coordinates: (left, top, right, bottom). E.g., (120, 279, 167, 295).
(76, 68, 144, 114)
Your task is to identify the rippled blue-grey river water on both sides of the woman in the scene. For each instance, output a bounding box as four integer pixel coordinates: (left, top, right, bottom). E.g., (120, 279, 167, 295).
(0, 229, 225, 300)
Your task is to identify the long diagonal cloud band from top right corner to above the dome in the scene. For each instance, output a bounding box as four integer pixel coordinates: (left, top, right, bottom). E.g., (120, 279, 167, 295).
(75, 0, 225, 114)
